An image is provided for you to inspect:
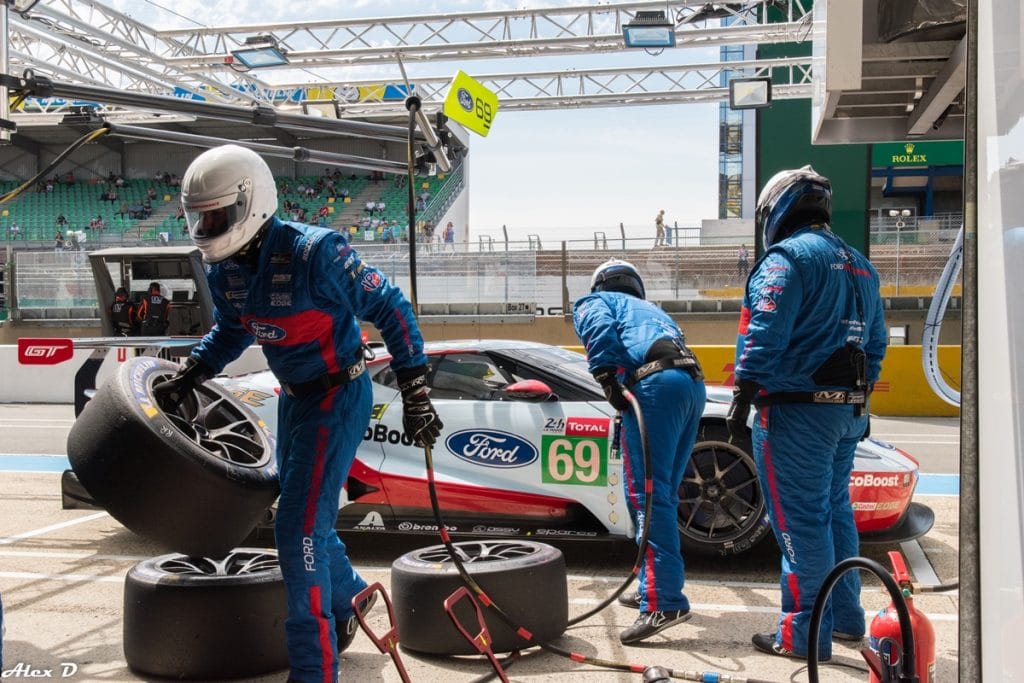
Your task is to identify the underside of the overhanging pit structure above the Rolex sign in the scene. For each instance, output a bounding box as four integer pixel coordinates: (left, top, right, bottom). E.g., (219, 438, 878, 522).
(811, 0, 967, 144)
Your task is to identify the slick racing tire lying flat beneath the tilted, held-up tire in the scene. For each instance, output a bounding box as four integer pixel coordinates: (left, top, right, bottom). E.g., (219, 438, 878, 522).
(123, 548, 288, 681)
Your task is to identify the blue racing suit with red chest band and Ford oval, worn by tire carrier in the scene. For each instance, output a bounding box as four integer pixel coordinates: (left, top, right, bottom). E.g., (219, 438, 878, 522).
(191, 218, 427, 683)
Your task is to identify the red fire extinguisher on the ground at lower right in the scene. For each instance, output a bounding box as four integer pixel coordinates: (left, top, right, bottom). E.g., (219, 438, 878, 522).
(868, 551, 935, 683)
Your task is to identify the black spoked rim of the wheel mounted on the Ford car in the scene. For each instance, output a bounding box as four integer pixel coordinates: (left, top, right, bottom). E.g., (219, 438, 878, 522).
(679, 441, 764, 544)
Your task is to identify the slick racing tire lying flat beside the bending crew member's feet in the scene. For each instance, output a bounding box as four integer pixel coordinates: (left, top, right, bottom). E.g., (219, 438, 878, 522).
(391, 540, 568, 654)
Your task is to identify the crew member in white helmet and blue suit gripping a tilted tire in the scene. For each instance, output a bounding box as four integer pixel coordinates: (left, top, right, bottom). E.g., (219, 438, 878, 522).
(154, 144, 442, 683)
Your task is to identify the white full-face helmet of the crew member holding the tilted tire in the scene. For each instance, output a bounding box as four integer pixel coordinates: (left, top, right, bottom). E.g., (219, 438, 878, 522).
(181, 144, 278, 263)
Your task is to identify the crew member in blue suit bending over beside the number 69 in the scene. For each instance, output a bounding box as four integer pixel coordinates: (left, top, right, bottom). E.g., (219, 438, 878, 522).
(572, 259, 706, 644)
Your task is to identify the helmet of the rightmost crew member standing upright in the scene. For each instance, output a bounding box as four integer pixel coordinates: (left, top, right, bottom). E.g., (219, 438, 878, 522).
(754, 165, 831, 249)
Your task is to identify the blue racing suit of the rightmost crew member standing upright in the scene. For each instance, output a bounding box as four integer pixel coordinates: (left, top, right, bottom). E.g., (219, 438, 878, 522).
(735, 225, 887, 657)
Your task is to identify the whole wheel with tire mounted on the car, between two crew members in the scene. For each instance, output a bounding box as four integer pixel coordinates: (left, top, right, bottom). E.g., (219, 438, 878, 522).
(679, 425, 771, 555)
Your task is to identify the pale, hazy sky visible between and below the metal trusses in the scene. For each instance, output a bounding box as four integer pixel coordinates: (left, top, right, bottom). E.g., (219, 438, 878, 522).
(105, 0, 718, 242)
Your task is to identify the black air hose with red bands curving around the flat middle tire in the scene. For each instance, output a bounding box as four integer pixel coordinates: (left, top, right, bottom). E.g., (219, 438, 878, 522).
(415, 389, 770, 683)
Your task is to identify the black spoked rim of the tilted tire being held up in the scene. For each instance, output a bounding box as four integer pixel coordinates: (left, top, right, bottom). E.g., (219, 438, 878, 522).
(150, 376, 271, 468)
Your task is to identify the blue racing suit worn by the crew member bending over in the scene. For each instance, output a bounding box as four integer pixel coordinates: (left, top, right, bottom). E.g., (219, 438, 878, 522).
(572, 292, 706, 612)
